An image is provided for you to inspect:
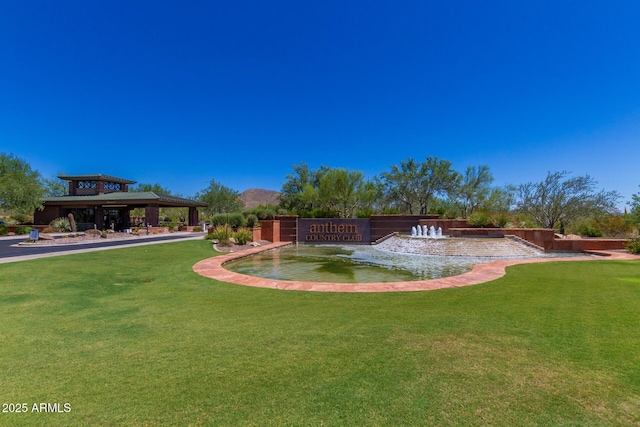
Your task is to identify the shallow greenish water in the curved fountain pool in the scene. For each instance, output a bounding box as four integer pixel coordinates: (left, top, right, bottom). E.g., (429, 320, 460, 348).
(224, 244, 495, 283)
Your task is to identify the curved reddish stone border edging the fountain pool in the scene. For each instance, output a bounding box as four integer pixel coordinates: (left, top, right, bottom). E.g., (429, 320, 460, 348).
(193, 242, 640, 292)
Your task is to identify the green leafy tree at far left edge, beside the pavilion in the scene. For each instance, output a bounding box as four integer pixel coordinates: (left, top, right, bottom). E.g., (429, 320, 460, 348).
(0, 153, 44, 215)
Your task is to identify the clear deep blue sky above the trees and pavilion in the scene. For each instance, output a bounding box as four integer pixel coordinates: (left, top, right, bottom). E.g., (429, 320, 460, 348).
(0, 0, 640, 207)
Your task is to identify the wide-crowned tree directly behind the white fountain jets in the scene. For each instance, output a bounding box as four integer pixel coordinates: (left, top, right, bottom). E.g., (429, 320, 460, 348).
(380, 156, 461, 214)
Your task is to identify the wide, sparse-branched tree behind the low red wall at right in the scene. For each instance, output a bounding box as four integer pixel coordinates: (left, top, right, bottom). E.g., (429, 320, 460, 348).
(514, 171, 620, 232)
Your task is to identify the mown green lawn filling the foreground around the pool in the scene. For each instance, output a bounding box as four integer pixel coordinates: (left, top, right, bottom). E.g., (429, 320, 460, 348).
(0, 241, 640, 426)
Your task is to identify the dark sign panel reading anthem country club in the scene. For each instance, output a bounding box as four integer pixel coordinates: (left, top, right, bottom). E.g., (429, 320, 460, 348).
(298, 218, 371, 245)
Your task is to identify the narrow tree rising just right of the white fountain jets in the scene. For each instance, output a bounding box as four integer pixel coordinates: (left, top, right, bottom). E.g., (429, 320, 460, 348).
(451, 165, 493, 218)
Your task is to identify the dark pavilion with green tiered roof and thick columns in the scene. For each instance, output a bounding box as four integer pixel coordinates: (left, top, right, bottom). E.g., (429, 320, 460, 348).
(34, 174, 207, 230)
